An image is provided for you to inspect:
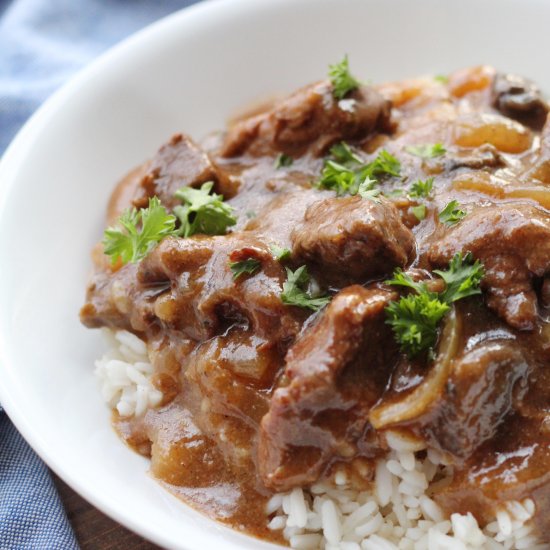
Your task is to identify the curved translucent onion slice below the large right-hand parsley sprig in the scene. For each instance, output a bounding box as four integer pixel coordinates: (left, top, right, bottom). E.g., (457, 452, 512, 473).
(369, 308, 462, 429)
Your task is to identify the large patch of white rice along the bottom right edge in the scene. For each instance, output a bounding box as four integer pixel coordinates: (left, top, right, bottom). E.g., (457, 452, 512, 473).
(266, 433, 550, 550)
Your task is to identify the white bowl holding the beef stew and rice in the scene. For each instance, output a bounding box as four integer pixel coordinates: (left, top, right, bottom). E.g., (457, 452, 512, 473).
(0, 0, 550, 550)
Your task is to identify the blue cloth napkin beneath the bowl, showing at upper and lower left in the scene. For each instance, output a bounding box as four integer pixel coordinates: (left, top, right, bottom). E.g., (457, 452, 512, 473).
(0, 0, 198, 550)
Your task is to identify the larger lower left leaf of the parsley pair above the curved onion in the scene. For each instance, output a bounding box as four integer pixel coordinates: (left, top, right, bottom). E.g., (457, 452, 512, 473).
(386, 296, 450, 357)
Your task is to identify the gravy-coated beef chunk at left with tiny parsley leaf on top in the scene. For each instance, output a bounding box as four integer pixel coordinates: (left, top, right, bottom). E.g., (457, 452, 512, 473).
(138, 234, 305, 345)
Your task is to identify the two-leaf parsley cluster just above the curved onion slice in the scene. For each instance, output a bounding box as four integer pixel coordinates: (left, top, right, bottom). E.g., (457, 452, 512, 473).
(386, 253, 484, 357)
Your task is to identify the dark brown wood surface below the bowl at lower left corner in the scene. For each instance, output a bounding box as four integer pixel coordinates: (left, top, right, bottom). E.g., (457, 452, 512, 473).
(52, 473, 159, 550)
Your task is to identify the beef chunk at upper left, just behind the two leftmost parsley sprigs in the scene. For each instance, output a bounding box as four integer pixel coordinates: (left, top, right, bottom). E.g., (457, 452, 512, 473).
(134, 134, 224, 208)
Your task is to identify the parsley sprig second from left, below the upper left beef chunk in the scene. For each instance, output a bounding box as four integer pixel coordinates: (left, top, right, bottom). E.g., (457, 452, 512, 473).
(174, 181, 237, 237)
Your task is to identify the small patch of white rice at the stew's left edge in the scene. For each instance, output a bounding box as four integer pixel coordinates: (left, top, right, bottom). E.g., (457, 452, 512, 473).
(95, 329, 162, 416)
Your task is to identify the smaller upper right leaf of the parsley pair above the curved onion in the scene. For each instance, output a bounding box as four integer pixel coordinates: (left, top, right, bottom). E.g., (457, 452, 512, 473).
(434, 252, 485, 304)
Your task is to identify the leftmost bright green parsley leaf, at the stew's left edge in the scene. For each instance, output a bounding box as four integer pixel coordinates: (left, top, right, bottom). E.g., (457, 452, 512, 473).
(102, 197, 176, 264)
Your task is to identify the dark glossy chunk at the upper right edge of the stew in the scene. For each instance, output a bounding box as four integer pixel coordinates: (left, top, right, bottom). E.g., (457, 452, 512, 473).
(492, 74, 548, 130)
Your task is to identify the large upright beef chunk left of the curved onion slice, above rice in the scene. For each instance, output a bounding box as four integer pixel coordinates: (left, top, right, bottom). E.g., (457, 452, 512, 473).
(258, 285, 397, 491)
